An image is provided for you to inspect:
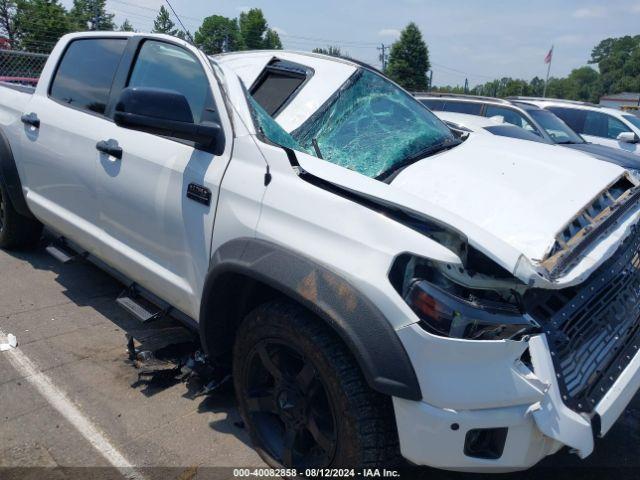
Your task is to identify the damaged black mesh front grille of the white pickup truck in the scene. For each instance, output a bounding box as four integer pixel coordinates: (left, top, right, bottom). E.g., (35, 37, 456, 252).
(524, 228, 640, 412)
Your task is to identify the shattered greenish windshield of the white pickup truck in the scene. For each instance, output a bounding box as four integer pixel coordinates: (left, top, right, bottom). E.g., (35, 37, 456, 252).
(291, 69, 455, 178)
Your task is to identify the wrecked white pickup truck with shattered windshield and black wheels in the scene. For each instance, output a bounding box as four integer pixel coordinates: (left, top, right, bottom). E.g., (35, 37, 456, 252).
(0, 32, 640, 473)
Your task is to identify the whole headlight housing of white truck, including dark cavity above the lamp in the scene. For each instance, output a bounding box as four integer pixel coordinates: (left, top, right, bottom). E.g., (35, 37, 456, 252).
(390, 255, 540, 340)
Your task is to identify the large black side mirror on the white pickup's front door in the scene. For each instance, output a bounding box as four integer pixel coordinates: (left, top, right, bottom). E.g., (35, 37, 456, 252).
(114, 87, 224, 153)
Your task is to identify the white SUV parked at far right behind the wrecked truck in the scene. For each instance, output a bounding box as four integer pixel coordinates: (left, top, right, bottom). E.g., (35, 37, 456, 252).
(514, 97, 640, 155)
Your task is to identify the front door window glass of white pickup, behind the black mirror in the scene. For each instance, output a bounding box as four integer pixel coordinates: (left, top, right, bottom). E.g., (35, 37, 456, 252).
(127, 40, 210, 123)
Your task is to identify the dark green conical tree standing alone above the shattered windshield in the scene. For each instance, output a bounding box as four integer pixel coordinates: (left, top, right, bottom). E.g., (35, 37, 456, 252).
(386, 22, 430, 91)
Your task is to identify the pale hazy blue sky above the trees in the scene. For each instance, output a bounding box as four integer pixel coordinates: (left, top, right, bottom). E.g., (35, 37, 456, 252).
(62, 0, 640, 86)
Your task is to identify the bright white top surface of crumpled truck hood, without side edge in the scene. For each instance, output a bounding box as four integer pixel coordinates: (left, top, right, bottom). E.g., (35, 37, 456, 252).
(392, 135, 623, 262)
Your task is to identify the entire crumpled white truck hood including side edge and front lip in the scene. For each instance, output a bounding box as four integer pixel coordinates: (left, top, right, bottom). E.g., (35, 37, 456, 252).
(288, 129, 639, 288)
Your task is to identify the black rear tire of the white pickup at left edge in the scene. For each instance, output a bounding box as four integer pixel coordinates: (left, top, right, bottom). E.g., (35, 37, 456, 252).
(0, 182, 42, 249)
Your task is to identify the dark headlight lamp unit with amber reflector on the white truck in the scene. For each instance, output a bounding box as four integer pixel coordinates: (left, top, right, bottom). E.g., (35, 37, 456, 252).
(405, 280, 540, 340)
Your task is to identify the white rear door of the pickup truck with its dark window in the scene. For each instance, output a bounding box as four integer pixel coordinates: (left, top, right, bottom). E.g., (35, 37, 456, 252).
(19, 37, 127, 249)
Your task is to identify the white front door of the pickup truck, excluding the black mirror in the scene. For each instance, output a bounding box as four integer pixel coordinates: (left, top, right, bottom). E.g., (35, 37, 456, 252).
(93, 38, 232, 318)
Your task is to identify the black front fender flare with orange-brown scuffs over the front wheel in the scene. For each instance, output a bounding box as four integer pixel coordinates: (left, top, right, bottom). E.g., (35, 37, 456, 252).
(199, 238, 422, 400)
